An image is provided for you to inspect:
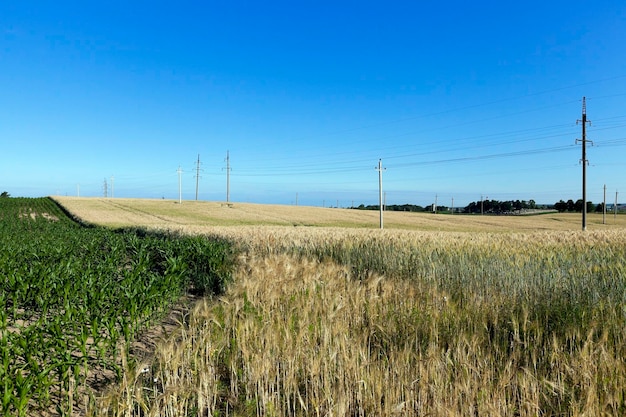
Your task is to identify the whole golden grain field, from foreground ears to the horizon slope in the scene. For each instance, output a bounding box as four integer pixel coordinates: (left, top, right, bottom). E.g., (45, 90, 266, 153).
(48, 198, 626, 416)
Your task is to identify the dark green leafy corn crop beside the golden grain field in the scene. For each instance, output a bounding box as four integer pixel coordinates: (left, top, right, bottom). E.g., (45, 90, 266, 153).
(0, 198, 232, 415)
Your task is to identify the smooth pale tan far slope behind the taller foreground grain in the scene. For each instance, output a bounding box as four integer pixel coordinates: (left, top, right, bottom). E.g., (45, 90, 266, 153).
(54, 197, 626, 232)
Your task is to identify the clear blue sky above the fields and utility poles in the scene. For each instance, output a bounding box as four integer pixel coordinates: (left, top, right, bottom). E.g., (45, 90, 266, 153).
(0, 0, 626, 207)
